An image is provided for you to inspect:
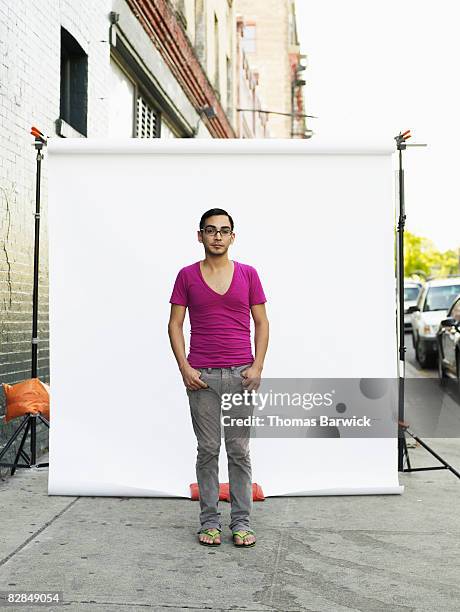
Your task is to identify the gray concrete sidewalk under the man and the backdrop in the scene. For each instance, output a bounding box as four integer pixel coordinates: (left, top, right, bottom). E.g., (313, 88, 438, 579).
(0, 439, 460, 612)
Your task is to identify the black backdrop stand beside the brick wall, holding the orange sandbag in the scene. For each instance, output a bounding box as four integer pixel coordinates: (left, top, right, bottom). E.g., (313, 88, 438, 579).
(0, 127, 49, 475)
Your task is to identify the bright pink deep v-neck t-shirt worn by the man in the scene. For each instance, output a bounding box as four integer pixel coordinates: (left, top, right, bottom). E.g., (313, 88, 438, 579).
(169, 261, 267, 368)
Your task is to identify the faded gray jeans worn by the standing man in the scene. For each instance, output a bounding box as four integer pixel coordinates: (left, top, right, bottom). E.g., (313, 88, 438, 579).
(187, 363, 253, 533)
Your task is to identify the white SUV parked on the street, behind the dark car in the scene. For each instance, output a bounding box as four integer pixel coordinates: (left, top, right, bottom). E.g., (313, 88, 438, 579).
(408, 276, 460, 368)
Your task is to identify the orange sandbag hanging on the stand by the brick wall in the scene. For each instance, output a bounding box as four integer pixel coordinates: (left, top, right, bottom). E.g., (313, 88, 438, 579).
(2, 378, 50, 423)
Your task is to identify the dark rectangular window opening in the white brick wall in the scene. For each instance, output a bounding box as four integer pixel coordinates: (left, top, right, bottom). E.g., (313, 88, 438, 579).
(60, 28, 88, 136)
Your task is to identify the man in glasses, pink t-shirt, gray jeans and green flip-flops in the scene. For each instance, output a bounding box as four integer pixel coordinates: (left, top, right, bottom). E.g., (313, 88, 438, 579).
(168, 208, 269, 547)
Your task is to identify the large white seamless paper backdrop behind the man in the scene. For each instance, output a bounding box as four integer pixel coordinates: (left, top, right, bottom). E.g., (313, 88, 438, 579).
(47, 139, 403, 497)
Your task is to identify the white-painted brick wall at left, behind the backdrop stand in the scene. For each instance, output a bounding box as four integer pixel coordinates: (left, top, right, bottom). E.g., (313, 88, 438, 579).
(0, 0, 111, 460)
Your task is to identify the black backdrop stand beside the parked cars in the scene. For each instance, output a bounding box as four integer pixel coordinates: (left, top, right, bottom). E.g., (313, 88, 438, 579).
(395, 130, 460, 478)
